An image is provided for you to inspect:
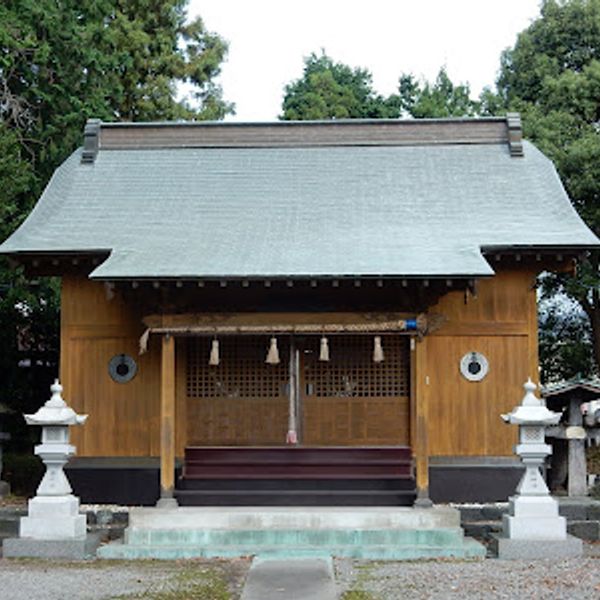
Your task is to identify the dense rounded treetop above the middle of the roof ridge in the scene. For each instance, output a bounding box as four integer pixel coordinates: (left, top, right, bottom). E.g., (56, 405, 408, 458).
(280, 52, 400, 120)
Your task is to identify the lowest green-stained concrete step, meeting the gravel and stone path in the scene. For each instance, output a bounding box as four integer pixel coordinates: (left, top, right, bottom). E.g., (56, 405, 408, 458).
(97, 539, 485, 560)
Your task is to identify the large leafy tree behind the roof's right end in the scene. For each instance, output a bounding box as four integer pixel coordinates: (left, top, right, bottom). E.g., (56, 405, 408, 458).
(497, 0, 600, 376)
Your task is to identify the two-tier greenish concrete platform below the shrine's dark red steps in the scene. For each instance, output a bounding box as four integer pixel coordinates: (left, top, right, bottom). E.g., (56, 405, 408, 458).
(97, 507, 485, 560)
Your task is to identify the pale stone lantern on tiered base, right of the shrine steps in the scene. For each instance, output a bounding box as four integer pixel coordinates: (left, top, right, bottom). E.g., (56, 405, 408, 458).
(496, 379, 582, 558)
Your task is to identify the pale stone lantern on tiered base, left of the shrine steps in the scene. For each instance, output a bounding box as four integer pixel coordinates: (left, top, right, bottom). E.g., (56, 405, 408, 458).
(3, 380, 97, 558)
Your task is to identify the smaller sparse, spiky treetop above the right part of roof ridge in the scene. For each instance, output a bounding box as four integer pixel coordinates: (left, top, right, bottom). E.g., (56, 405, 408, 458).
(398, 67, 480, 118)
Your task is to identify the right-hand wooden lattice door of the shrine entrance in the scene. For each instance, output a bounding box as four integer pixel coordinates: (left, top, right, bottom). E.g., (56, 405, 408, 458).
(302, 335, 410, 446)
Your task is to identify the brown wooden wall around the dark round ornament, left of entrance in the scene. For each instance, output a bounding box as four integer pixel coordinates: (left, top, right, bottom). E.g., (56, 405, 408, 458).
(60, 277, 160, 456)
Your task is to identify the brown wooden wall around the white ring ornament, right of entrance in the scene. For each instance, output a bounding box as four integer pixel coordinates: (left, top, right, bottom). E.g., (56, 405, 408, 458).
(423, 270, 539, 456)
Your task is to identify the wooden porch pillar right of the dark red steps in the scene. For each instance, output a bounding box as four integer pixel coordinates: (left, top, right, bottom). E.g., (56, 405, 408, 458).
(413, 338, 432, 508)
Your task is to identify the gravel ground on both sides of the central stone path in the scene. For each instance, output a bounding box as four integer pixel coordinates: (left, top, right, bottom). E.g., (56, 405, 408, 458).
(0, 544, 600, 600)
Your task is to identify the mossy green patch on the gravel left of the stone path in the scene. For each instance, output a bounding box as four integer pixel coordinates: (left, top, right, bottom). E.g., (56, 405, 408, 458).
(112, 567, 231, 600)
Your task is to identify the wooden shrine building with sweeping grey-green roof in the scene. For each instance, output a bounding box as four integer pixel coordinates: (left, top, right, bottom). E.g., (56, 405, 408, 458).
(0, 114, 600, 506)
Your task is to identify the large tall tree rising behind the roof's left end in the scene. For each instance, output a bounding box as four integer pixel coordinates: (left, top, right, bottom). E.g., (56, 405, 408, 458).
(0, 0, 233, 188)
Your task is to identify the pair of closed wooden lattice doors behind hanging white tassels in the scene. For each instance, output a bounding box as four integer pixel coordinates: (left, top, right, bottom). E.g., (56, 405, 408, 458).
(186, 335, 410, 446)
